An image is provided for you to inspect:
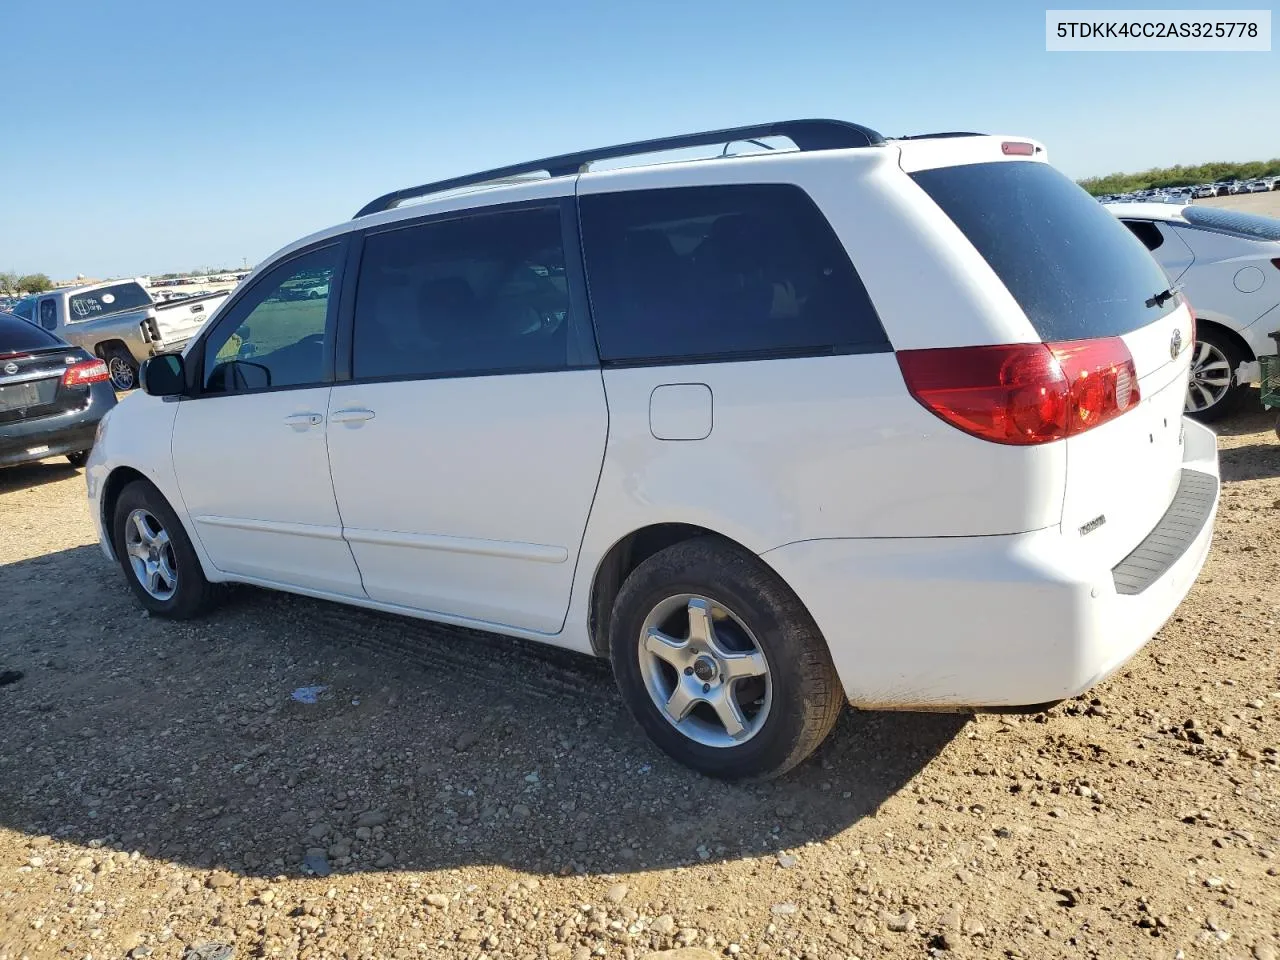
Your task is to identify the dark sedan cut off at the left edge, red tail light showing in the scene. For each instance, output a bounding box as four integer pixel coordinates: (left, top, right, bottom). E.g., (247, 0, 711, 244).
(0, 312, 115, 467)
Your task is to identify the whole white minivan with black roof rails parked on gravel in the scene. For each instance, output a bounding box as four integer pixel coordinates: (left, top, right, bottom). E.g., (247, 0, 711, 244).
(87, 120, 1219, 778)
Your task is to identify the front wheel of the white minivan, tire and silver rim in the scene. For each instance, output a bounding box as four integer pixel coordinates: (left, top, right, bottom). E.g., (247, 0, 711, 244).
(111, 480, 214, 620)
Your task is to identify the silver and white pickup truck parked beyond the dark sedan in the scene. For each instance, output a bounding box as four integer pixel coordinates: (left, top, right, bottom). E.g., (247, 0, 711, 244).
(13, 280, 230, 390)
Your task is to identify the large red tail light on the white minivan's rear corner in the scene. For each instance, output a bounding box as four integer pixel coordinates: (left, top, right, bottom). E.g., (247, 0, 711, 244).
(897, 337, 1139, 445)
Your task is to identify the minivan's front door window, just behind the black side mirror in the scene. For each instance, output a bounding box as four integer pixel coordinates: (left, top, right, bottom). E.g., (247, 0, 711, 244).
(205, 244, 342, 393)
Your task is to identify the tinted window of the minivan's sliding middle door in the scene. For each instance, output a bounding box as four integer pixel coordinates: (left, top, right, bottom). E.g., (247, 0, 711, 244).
(352, 206, 573, 379)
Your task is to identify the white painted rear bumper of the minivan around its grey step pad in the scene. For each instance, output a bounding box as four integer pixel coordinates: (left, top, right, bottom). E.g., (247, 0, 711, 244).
(763, 420, 1219, 709)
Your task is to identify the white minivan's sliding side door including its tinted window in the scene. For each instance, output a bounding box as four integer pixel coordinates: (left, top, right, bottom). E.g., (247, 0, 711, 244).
(328, 194, 608, 634)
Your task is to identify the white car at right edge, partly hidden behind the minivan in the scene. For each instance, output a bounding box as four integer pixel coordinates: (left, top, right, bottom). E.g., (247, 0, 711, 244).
(1106, 204, 1280, 420)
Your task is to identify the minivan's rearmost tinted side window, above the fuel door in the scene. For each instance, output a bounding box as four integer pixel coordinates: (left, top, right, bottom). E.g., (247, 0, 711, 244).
(580, 184, 888, 361)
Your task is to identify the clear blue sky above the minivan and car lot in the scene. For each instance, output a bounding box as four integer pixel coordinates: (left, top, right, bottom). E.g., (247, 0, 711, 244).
(0, 0, 1280, 278)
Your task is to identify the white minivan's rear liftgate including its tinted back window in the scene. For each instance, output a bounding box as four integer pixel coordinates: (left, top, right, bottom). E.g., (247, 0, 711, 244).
(911, 161, 1192, 566)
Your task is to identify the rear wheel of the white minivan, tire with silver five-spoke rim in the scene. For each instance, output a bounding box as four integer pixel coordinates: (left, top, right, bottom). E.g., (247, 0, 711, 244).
(609, 536, 845, 780)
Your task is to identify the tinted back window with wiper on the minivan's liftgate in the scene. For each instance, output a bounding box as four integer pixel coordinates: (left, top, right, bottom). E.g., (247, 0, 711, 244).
(911, 161, 1178, 340)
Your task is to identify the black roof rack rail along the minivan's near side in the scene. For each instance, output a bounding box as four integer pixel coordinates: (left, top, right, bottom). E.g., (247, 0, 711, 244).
(355, 119, 884, 220)
